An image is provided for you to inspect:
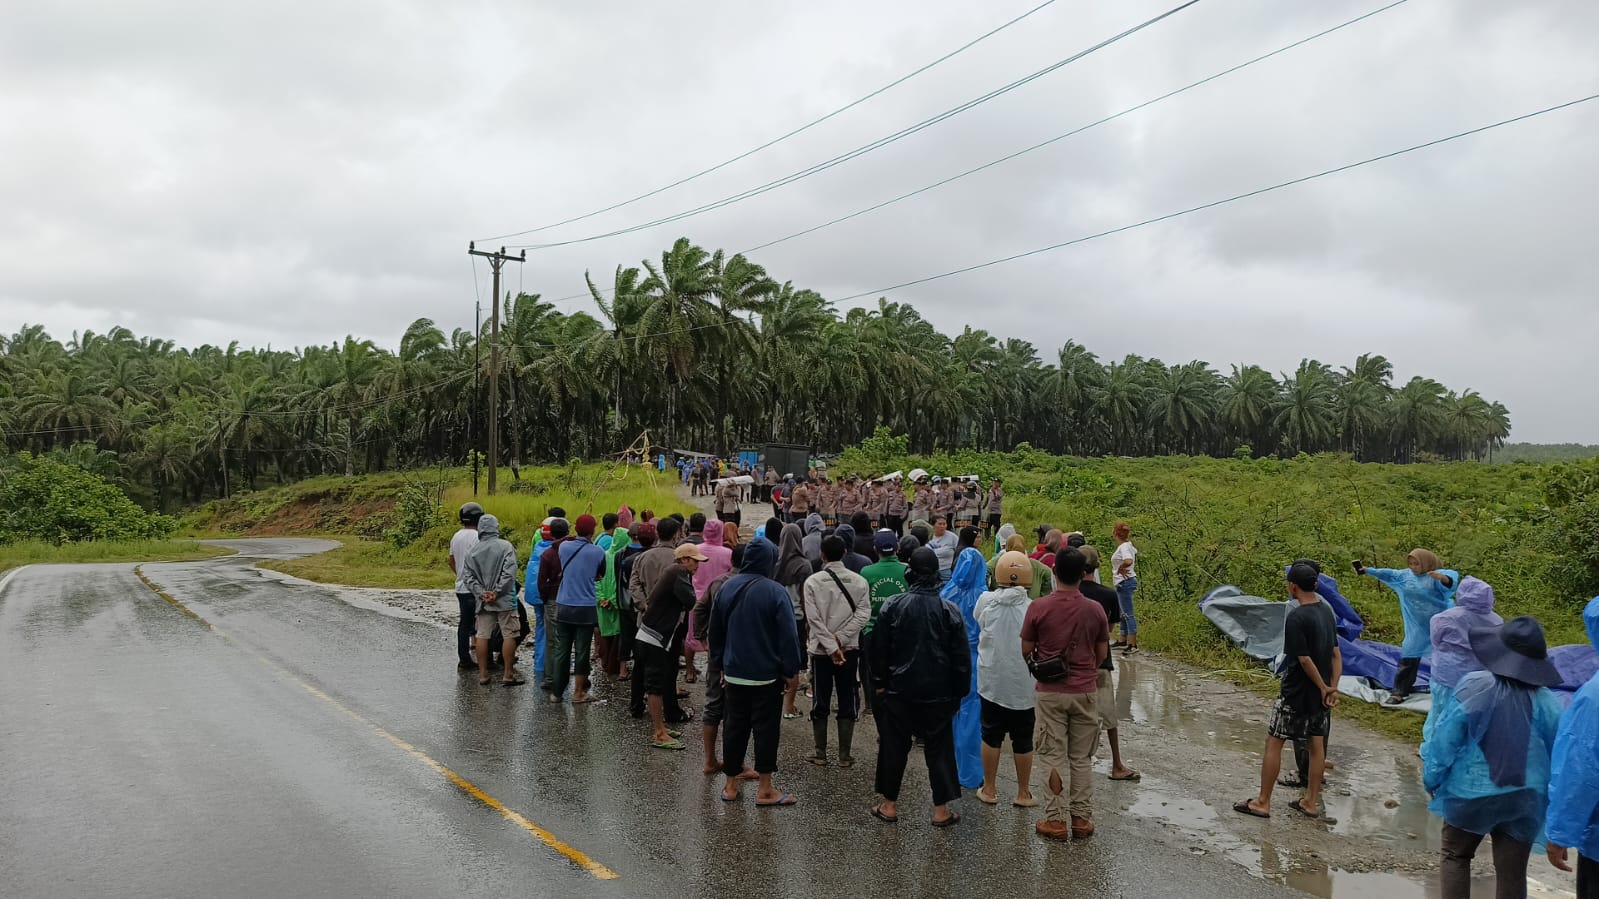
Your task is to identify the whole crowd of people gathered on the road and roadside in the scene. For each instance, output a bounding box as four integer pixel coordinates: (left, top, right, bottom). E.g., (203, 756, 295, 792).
(451, 483, 1599, 899)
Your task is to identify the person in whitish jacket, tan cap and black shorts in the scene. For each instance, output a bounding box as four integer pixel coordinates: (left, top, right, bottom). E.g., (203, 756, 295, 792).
(972, 552, 1038, 808)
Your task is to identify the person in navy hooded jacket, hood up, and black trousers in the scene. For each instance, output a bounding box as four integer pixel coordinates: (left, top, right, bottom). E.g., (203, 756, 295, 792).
(710, 537, 801, 808)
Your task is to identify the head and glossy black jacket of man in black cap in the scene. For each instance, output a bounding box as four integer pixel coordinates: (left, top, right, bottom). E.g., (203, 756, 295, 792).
(868, 547, 972, 703)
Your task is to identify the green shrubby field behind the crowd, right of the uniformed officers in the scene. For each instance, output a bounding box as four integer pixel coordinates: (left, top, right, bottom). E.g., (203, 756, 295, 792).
(835, 448, 1588, 741)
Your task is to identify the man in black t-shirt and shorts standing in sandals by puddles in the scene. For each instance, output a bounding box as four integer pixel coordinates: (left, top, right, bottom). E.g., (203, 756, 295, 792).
(1233, 561, 1343, 817)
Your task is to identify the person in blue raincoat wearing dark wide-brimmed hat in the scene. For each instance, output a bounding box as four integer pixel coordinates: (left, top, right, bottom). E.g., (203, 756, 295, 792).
(1422, 617, 1560, 899)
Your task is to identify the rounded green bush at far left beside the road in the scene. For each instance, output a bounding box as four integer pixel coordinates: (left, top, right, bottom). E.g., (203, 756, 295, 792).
(0, 453, 177, 545)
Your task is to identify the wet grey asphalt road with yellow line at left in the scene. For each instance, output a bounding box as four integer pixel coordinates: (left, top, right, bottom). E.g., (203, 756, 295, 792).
(0, 541, 1294, 899)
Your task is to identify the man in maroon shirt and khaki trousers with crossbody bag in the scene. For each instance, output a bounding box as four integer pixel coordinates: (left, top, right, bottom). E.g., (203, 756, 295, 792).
(1022, 547, 1110, 840)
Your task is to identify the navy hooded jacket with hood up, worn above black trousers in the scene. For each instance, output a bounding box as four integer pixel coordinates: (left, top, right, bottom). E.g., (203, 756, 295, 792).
(710, 528, 801, 681)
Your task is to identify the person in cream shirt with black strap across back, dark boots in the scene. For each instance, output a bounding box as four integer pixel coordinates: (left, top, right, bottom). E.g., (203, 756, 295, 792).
(804, 536, 871, 768)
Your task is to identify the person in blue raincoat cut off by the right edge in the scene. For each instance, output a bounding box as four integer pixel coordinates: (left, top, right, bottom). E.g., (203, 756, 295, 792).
(1545, 597, 1599, 899)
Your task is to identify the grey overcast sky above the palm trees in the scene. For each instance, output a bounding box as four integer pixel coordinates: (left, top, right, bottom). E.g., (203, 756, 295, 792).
(0, 0, 1599, 443)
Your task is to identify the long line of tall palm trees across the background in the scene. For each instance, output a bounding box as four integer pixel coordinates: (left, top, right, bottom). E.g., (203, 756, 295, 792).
(0, 238, 1509, 509)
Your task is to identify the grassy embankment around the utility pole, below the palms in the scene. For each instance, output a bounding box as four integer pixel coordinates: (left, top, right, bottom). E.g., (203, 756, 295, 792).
(185, 465, 692, 590)
